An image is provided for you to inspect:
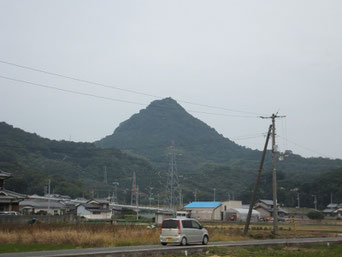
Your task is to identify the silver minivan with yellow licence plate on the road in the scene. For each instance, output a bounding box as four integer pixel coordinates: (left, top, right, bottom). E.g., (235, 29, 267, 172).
(160, 218, 209, 245)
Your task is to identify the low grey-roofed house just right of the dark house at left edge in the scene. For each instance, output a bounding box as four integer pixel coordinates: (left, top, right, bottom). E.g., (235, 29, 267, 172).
(19, 199, 67, 215)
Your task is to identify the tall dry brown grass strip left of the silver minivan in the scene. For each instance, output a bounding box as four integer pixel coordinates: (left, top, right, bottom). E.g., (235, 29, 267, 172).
(0, 224, 159, 247)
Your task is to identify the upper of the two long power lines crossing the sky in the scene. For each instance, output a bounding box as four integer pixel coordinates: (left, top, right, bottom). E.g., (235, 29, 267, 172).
(0, 60, 260, 115)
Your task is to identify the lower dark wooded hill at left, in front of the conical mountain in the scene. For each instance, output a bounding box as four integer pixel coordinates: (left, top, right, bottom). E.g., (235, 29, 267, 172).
(0, 122, 161, 202)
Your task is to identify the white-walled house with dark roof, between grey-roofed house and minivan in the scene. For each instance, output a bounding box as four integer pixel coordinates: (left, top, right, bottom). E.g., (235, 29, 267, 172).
(76, 199, 113, 220)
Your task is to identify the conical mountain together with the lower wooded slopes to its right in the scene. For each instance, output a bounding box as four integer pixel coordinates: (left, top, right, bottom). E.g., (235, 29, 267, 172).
(95, 98, 342, 206)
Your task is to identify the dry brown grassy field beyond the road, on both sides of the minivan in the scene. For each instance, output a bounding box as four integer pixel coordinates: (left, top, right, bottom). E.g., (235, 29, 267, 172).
(0, 223, 342, 253)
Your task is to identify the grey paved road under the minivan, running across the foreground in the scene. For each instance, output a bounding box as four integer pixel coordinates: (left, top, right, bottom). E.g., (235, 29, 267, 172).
(0, 237, 342, 257)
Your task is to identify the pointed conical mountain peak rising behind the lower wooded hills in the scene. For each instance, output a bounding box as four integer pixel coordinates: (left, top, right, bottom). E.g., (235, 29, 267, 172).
(97, 98, 259, 170)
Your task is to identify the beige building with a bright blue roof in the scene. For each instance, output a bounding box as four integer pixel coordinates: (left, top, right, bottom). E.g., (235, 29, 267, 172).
(183, 201, 242, 220)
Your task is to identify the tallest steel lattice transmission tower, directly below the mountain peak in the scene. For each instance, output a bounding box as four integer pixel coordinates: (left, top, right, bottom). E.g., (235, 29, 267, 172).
(167, 144, 182, 209)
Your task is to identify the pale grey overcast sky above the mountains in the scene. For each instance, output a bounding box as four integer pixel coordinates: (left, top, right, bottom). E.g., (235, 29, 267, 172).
(0, 0, 342, 158)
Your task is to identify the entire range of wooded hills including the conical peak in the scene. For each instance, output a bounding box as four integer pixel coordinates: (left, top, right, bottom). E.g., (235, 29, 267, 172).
(0, 98, 342, 207)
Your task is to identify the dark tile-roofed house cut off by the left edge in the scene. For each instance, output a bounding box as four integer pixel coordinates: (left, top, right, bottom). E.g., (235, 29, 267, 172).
(0, 170, 26, 211)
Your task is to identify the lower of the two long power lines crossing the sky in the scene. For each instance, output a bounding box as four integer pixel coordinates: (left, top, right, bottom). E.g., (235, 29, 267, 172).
(0, 75, 257, 118)
